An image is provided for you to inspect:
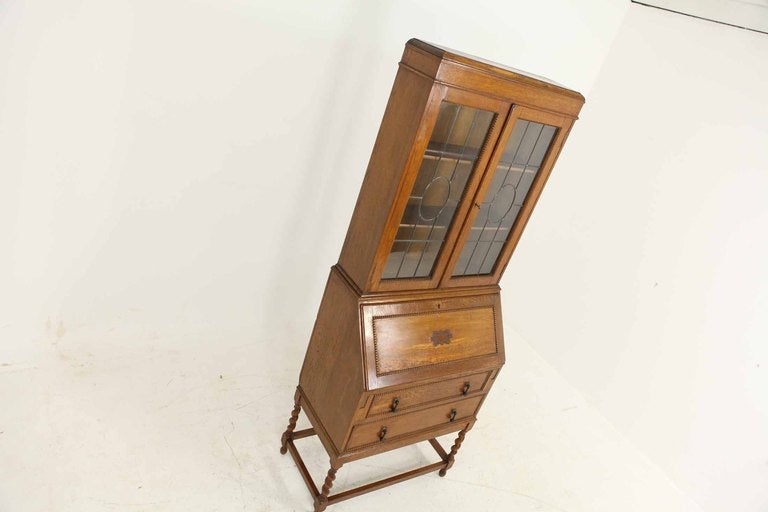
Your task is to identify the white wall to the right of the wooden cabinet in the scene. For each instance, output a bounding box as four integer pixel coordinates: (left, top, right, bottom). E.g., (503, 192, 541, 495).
(503, 5, 768, 512)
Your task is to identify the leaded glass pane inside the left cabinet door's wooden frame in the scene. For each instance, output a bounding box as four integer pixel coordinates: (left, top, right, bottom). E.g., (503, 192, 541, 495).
(382, 101, 495, 279)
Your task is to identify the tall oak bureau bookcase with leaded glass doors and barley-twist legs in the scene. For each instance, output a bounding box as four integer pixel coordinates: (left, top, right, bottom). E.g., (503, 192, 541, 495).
(281, 40, 584, 511)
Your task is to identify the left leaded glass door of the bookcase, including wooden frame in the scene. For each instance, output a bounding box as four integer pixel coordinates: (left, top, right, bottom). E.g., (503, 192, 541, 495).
(379, 88, 510, 290)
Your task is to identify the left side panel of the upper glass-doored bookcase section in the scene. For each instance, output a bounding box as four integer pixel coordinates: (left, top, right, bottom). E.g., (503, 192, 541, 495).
(339, 67, 433, 290)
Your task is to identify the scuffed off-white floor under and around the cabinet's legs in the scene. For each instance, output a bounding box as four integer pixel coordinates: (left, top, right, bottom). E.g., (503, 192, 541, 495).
(0, 325, 699, 512)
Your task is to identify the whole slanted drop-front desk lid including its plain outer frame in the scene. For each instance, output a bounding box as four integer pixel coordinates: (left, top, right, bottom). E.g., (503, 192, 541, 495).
(364, 295, 503, 380)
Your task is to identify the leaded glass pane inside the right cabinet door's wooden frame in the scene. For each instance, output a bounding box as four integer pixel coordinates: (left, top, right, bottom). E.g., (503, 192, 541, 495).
(453, 119, 557, 276)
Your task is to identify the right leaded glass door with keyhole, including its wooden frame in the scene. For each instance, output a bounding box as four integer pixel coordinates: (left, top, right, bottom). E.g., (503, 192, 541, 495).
(443, 107, 572, 286)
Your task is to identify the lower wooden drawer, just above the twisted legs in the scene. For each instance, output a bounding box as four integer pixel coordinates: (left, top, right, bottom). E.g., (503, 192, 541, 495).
(347, 395, 483, 449)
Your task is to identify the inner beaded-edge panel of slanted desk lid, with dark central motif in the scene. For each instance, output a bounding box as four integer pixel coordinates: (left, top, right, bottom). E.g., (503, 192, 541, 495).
(373, 306, 497, 375)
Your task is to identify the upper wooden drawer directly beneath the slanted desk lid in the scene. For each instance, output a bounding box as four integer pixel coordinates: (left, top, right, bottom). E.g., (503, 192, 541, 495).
(368, 372, 490, 416)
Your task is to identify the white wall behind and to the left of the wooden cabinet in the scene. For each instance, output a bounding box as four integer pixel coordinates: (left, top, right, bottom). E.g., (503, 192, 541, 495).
(0, 0, 626, 352)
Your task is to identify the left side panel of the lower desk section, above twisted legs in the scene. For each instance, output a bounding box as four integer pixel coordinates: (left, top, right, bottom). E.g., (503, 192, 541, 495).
(299, 271, 365, 450)
